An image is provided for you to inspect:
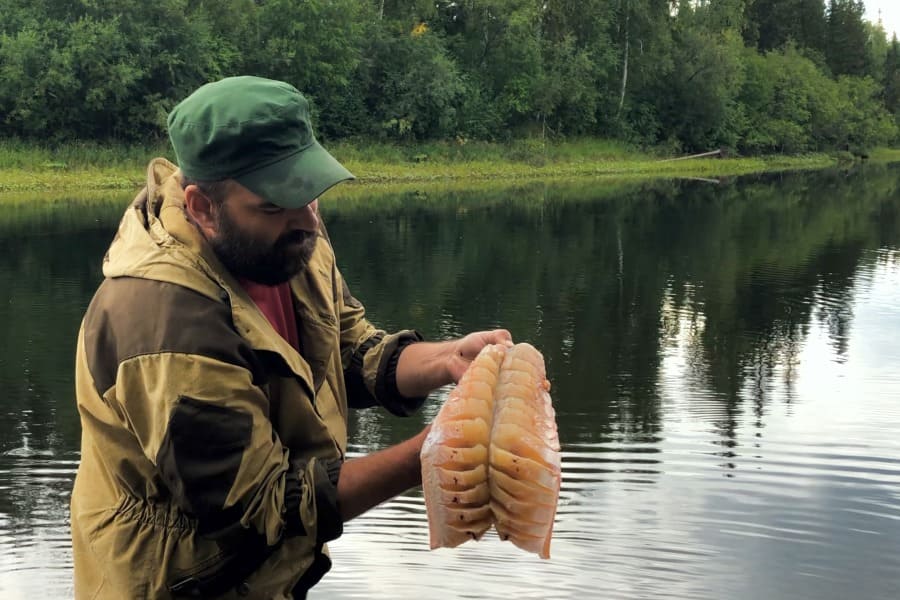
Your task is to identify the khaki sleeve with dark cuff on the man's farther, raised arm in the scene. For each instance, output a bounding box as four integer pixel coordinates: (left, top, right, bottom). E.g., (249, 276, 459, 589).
(334, 268, 425, 417)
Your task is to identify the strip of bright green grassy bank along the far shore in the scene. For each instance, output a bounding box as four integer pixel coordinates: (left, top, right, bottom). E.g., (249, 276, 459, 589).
(0, 139, 900, 195)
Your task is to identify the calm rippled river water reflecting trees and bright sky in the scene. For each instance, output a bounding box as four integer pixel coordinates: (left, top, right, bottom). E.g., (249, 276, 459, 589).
(0, 167, 900, 600)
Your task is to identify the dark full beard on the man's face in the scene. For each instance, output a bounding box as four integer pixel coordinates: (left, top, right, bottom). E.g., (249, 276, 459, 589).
(209, 206, 318, 285)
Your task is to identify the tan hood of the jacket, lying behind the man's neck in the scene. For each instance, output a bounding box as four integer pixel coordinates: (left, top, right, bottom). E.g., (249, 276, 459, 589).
(103, 158, 230, 298)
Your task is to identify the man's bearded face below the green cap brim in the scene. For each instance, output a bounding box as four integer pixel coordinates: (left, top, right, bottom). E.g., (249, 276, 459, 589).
(209, 185, 319, 285)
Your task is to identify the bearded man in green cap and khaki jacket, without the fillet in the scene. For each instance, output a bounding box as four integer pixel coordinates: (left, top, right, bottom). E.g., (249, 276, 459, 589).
(71, 77, 511, 600)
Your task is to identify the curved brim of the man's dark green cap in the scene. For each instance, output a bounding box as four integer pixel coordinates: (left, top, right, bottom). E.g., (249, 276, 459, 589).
(235, 142, 356, 208)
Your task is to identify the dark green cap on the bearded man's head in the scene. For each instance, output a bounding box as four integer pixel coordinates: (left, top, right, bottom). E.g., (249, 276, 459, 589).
(167, 76, 354, 208)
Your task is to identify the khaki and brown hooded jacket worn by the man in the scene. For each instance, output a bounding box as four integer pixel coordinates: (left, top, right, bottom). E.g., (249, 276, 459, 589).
(71, 159, 422, 600)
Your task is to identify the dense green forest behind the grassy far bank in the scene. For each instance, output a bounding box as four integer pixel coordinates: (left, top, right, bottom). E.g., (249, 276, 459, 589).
(0, 0, 900, 153)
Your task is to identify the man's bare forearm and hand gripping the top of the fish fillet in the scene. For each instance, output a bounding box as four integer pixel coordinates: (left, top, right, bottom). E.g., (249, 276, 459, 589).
(397, 329, 513, 398)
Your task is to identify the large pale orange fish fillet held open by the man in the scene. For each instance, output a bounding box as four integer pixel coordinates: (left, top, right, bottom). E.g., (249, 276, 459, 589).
(421, 344, 562, 558)
